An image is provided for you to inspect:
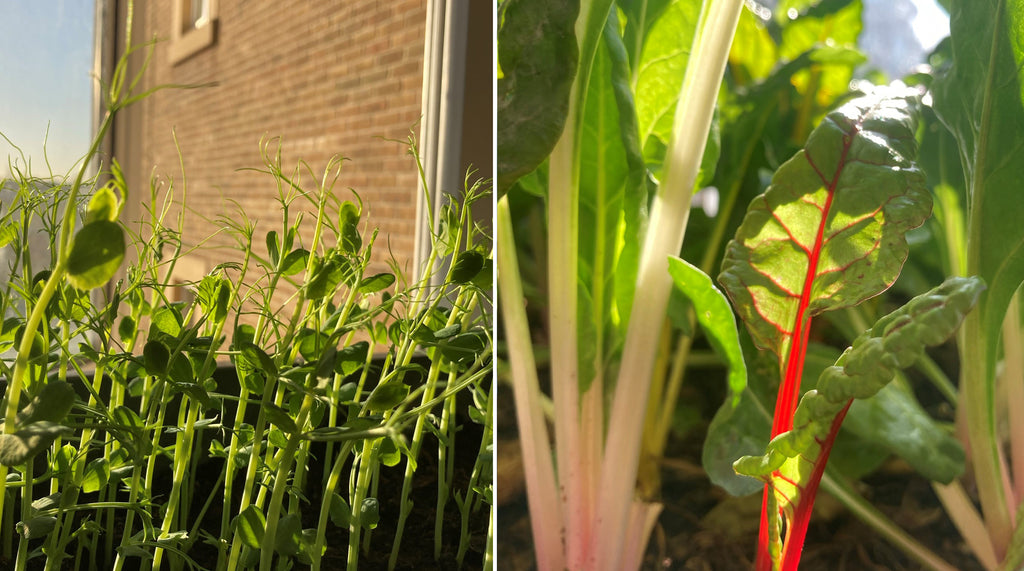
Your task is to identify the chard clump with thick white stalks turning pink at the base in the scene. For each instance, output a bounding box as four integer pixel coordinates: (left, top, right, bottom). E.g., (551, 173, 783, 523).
(497, 0, 743, 569)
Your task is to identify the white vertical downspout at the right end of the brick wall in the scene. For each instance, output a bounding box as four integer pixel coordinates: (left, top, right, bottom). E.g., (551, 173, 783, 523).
(414, 0, 469, 282)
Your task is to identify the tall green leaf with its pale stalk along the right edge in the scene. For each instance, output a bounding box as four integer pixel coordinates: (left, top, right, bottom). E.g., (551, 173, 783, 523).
(933, 0, 1024, 540)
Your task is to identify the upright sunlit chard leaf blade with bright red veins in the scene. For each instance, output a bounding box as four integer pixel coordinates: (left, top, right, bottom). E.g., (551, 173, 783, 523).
(719, 90, 932, 363)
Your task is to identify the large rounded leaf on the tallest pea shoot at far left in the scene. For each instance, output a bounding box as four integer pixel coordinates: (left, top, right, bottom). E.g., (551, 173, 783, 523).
(68, 220, 125, 290)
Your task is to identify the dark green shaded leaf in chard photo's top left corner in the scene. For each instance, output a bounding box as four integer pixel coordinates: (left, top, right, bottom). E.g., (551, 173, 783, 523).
(497, 0, 580, 194)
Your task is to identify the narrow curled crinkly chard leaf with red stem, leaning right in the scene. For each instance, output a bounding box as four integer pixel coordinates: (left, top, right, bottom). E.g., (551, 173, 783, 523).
(733, 277, 985, 557)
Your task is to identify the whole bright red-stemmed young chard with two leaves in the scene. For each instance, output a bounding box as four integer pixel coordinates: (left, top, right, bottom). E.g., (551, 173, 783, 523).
(719, 88, 983, 571)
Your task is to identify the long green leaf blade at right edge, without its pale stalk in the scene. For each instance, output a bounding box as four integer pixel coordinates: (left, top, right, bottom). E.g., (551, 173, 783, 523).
(934, 0, 1024, 358)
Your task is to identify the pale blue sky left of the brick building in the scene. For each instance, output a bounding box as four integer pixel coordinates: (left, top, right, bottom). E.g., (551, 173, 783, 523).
(0, 0, 95, 176)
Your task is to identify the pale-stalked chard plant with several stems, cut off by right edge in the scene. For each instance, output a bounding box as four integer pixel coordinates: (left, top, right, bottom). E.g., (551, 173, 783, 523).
(913, 0, 1024, 570)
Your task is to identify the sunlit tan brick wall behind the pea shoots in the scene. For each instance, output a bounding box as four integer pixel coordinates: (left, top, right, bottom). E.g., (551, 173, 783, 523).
(114, 0, 426, 288)
